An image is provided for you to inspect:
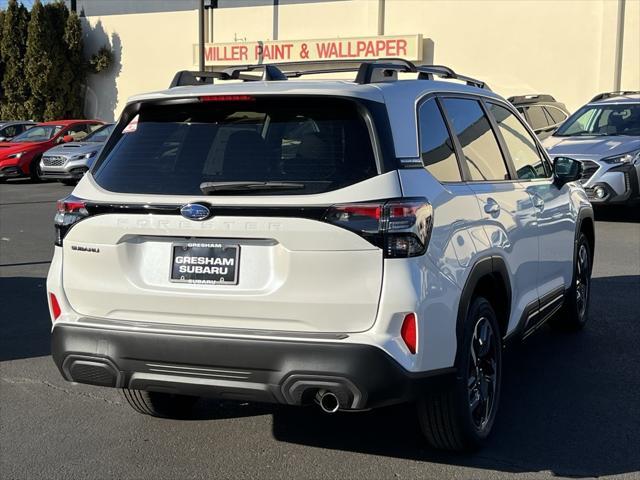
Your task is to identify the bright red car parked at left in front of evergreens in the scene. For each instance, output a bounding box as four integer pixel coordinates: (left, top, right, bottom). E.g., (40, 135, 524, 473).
(0, 120, 103, 181)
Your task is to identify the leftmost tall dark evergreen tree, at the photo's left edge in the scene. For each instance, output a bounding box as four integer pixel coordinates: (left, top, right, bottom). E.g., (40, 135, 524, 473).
(0, 0, 31, 120)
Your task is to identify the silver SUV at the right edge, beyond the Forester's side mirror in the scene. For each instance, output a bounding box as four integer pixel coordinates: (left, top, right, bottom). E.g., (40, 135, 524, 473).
(542, 92, 640, 205)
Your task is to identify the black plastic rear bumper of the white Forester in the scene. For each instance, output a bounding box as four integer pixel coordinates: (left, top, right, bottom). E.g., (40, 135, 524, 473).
(52, 324, 455, 410)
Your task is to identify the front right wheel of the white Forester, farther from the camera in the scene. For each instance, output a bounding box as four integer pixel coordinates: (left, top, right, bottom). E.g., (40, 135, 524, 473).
(549, 232, 593, 332)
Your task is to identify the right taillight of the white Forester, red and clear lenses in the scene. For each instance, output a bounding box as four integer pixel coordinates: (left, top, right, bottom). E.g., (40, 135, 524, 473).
(324, 198, 433, 258)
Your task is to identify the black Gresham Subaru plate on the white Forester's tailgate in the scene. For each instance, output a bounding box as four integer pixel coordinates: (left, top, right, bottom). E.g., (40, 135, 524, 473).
(171, 242, 240, 285)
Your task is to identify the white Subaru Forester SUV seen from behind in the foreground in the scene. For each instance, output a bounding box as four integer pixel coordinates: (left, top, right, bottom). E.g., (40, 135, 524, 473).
(47, 60, 594, 450)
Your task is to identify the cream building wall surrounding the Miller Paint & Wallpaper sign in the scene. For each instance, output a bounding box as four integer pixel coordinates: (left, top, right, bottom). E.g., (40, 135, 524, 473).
(86, 0, 640, 120)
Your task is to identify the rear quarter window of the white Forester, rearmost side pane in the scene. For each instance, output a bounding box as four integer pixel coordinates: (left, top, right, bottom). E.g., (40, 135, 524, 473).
(418, 98, 462, 182)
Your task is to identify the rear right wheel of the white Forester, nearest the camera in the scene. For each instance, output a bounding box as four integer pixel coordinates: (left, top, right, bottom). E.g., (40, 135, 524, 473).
(417, 297, 502, 452)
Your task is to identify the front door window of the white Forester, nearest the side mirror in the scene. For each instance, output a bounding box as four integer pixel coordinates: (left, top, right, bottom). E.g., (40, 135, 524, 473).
(488, 103, 547, 180)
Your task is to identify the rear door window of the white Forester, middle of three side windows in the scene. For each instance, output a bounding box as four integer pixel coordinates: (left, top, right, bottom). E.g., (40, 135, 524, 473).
(443, 98, 509, 181)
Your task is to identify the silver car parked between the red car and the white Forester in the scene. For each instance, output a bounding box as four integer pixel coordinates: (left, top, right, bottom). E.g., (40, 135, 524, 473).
(40, 124, 113, 184)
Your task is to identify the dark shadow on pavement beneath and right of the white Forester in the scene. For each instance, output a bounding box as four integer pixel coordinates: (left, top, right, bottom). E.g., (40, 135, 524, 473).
(273, 276, 640, 477)
